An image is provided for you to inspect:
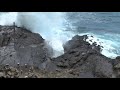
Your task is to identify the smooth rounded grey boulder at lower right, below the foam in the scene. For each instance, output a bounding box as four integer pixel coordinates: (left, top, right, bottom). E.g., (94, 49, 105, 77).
(87, 55, 113, 78)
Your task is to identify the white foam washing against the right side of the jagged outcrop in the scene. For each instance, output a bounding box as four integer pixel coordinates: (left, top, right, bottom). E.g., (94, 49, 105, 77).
(79, 33, 119, 58)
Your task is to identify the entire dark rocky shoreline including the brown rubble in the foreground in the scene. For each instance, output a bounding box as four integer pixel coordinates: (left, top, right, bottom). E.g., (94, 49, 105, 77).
(0, 26, 120, 78)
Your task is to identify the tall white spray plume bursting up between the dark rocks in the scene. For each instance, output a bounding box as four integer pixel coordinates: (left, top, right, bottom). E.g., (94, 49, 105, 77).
(16, 12, 73, 57)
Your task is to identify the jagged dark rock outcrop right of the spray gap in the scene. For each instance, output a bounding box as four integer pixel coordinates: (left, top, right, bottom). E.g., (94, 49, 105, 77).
(53, 35, 113, 78)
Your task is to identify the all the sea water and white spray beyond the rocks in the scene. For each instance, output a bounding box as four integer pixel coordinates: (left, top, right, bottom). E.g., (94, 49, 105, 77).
(0, 12, 120, 58)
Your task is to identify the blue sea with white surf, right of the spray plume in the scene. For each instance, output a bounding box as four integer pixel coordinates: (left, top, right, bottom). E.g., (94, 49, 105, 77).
(67, 12, 120, 58)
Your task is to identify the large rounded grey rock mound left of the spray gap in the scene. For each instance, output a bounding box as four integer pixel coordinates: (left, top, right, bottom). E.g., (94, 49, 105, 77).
(0, 26, 53, 67)
